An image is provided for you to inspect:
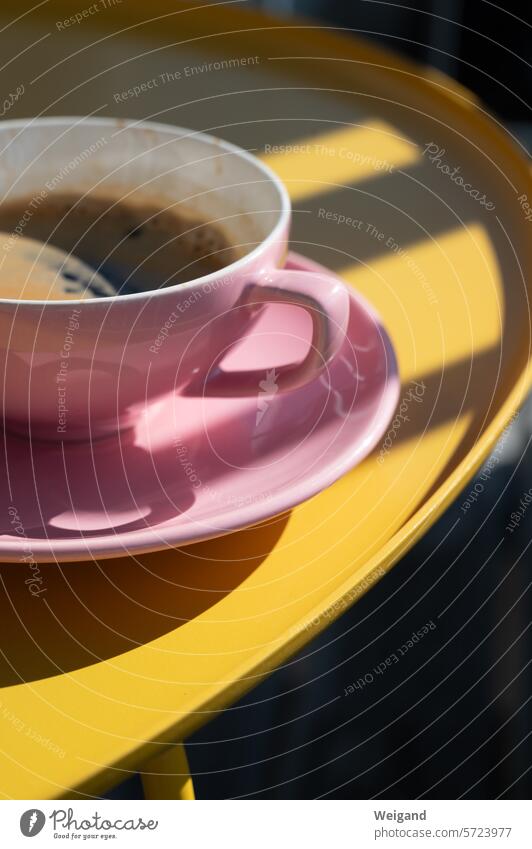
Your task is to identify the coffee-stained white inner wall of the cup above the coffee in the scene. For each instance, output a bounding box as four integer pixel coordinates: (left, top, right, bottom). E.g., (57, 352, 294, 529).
(0, 118, 288, 255)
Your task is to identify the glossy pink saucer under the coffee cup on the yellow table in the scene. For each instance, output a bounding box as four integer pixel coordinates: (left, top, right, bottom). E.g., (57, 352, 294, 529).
(0, 254, 399, 562)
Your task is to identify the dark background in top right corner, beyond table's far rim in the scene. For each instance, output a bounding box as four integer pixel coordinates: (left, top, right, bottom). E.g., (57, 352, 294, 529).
(253, 0, 532, 121)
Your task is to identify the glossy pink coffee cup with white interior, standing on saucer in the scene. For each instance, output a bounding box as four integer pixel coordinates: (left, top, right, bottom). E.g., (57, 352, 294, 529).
(0, 118, 349, 441)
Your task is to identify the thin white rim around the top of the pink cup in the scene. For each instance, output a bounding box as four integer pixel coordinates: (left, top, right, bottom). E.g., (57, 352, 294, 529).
(0, 115, 291, 308)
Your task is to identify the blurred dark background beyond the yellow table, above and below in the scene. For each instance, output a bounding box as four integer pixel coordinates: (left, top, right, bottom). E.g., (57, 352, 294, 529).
(106, 0, 532, 799)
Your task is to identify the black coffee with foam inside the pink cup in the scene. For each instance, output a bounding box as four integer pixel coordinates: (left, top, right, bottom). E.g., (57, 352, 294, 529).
(0, 194, 239, 300)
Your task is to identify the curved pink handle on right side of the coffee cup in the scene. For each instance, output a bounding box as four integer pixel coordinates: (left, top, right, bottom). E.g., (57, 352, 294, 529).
(203, 269, 349, 397)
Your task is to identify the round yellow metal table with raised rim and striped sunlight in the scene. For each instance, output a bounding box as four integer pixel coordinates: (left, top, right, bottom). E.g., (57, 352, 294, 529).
(0, 0, 532, 798)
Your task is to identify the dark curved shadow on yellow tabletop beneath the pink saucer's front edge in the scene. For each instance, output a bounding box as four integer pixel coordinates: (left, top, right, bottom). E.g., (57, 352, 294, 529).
(0, 514, 289, 687)
